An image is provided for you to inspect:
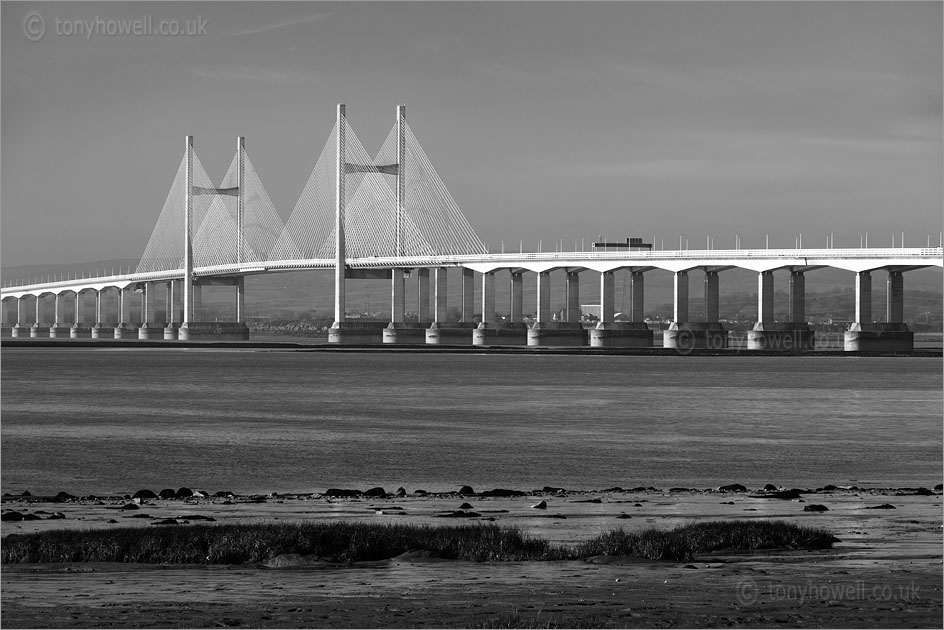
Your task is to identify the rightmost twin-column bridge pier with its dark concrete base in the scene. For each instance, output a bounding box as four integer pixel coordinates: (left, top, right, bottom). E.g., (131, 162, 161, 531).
(843, 269, 914, 352)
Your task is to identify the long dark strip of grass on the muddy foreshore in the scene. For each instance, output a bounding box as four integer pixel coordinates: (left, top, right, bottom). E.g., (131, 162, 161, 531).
(2, 521, 837, 564)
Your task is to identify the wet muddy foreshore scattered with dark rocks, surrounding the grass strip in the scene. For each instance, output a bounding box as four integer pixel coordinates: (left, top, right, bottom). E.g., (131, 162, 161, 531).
(0, 487, 944, 628)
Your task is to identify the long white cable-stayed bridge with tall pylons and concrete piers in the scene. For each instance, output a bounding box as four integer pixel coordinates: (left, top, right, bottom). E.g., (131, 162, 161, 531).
(2, 105, 944, 351)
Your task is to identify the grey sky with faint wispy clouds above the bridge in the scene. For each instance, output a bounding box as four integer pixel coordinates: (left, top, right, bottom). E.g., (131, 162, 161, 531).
(0, 1, 944, 267)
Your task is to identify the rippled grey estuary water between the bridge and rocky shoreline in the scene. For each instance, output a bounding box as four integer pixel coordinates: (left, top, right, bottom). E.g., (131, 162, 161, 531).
(0, 348, 942, 494)
